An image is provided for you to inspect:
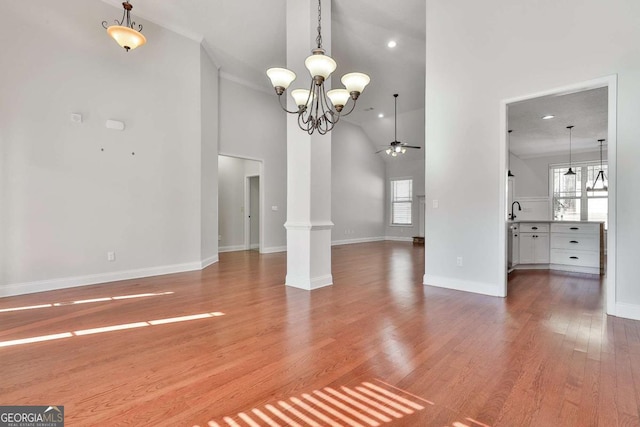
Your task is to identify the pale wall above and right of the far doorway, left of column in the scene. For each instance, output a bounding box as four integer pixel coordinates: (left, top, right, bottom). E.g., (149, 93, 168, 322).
(220, 78, 287, 252)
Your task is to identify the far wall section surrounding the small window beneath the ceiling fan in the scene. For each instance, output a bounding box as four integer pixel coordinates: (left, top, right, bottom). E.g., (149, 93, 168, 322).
(385, 157, 425, 241)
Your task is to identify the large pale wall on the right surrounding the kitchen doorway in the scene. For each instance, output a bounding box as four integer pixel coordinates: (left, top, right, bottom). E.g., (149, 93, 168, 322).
(425, 0, 640, 318)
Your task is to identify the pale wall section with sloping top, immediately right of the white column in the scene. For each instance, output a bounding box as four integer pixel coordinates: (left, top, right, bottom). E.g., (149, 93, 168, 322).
(331, 121, 385, 244)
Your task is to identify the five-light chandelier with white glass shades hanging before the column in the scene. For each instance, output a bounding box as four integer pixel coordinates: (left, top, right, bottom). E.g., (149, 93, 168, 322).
(267, 0, 370, 135)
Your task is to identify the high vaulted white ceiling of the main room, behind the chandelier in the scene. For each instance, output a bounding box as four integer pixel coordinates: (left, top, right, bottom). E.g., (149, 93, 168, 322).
(103, 0, 426, 157)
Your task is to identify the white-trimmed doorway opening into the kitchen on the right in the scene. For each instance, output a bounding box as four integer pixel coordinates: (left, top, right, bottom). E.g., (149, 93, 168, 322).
(500, 76, 617, 314)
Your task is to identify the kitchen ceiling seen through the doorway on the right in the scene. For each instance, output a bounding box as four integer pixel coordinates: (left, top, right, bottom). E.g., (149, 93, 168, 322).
(508, 88, 608, 158)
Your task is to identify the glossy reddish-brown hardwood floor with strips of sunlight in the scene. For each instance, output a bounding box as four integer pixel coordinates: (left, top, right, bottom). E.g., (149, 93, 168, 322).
(0, 242, 640, 427)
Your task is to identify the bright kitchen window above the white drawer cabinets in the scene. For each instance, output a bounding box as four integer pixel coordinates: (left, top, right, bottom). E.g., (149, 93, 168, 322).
(549, 163, 609, 228)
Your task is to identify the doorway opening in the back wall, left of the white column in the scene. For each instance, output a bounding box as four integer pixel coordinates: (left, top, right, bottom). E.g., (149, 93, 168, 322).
(218, 155, 264, 252)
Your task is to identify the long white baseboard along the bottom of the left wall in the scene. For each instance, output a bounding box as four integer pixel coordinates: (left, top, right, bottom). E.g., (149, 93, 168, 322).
(0, 256, 204, 297)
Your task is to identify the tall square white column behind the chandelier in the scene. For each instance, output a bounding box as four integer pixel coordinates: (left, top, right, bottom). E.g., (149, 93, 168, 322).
(285, 0, 333, 290)
